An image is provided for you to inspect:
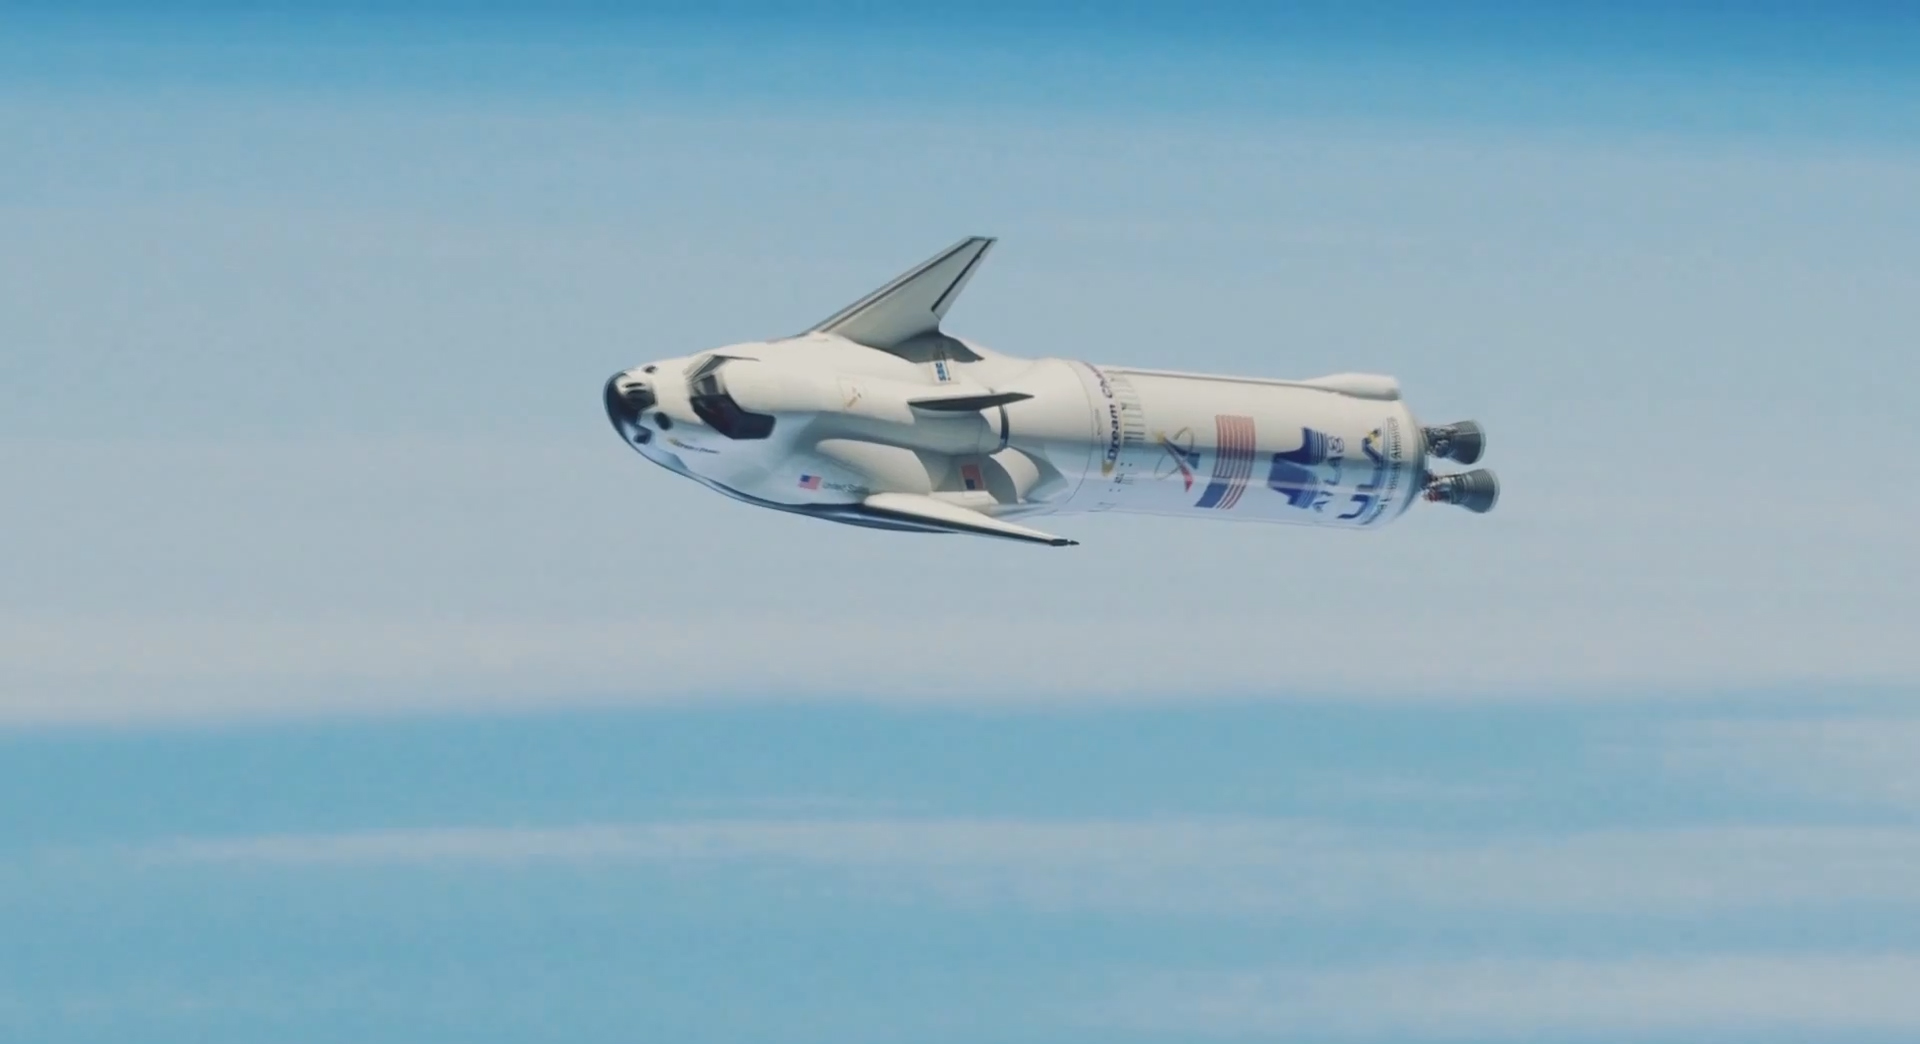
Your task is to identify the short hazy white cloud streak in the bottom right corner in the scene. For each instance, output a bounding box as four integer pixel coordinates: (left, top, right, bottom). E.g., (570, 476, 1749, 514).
(1085, 952, 1920, 1040)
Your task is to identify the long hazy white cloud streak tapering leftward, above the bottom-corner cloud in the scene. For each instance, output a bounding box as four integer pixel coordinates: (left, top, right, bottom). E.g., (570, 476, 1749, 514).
(132, 819, 1920, 914)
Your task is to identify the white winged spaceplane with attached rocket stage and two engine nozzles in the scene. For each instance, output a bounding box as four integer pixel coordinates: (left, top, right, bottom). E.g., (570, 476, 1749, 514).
(605, 238, 1500, 545)
